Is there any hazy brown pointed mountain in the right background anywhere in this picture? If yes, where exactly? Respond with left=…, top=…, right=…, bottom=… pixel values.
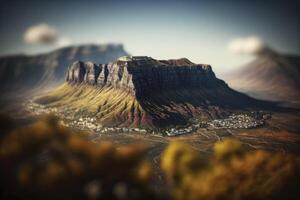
left=224, top=49, right=300, bottom=103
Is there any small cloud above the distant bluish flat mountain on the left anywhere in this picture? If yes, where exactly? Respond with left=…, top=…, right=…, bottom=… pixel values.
left=24, top=23, right=57, bottom=44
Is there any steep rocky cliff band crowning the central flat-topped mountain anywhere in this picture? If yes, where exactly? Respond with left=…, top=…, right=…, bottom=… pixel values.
left=66, top=57, right=226, bottom=97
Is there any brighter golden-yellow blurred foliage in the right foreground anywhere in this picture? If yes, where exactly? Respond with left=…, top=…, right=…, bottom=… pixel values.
left=161, top=140, right=300, bottom=200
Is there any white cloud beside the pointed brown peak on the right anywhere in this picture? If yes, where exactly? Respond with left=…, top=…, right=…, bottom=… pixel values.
left=228, top=36, right=266, bottom=54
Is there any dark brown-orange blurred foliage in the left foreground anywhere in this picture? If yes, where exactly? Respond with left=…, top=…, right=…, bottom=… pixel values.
left=0, top=116, right=156, bottom=199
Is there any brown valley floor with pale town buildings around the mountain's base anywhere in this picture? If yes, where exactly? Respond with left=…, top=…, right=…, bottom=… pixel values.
left=24, top=98, right=300, bottom=153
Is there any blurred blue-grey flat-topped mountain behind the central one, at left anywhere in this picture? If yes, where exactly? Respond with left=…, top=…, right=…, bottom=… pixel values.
left=0, top=44, right=128, bottom=94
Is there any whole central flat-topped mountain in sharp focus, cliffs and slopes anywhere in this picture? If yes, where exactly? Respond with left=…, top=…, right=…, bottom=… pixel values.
left=36, top=56, right=274, bottom=127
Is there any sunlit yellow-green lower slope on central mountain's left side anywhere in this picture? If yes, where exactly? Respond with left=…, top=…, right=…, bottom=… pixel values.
left=35, top=84, right=151, bottom=127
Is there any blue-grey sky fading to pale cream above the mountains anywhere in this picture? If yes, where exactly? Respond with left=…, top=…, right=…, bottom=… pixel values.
left=0, top=0, right=300, bottom=72
